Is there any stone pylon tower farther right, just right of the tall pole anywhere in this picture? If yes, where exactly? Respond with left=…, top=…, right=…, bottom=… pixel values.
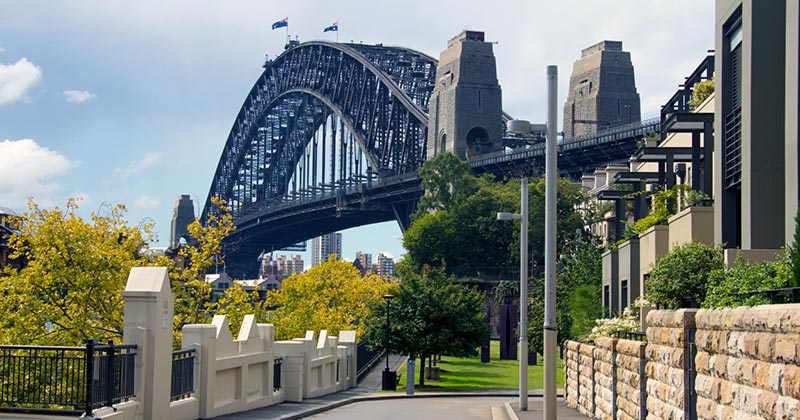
left=564, top=41, right=641, bottom=141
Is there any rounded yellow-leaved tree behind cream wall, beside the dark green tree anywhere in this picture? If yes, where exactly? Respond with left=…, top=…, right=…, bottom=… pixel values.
left=267, top=257, right=393, bottom=340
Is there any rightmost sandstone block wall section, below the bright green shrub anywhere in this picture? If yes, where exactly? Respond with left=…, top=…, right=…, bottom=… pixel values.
left=695, top=304, right=800, bottom=419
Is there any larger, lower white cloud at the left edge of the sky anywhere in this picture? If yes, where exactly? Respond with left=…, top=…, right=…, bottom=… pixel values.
left=0, top=139, right=78, bottom=209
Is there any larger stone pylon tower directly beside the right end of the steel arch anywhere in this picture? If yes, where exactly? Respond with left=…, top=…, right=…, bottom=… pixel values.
left=427, top=31, right=503, bottom=159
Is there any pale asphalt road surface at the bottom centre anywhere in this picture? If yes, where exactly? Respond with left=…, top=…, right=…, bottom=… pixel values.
left=309, top=397, right=513, bottom=420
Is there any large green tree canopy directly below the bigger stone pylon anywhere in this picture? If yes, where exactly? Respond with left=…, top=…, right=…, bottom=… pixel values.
left=403, top=153, right=585, bottom=276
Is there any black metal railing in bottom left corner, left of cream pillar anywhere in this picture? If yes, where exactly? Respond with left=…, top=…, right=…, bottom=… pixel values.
left=0, top=340, right=136, bottom=416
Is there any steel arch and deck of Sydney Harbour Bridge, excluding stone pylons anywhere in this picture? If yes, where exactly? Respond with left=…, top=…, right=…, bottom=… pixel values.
left=203, top=34, right=659, bottom=276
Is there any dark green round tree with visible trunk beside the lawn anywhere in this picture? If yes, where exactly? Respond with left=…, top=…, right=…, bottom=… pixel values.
left=366, top=263, right=489, bottom=386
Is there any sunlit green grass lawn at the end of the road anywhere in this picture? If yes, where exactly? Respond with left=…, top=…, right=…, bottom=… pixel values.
left=397, top=341, right=564, bottom=392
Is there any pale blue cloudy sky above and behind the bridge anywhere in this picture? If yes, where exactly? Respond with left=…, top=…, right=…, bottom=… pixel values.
left=0, top=0, right=714, bottom=266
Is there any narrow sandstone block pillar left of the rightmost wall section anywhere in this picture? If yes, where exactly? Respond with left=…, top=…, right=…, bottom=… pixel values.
left=645, top=309, right=697, bottom=420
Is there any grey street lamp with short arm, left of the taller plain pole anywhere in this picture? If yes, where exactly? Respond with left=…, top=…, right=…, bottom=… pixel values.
left=497, top=178, right=528, bottom=411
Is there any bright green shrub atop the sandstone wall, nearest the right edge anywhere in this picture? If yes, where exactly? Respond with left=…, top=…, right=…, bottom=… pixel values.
left=703, top=254, right=791, bottom=308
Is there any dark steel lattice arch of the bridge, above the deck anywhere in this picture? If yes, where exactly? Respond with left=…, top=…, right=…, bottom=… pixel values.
left=203, top=41, right=437, bottom=224
